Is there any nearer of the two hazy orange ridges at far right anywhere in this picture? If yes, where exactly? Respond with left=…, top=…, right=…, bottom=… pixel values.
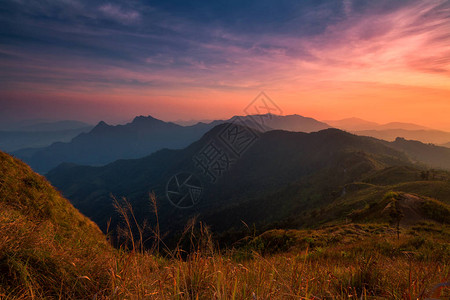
left=352, top=129, right=450, bottom=145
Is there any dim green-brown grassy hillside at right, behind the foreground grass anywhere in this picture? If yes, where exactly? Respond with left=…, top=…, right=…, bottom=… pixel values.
left=207, top=166, right=450, bottom=243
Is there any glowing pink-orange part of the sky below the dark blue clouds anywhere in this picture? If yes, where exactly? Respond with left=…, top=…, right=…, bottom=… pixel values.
left=0, top=0, right=450, bottom=131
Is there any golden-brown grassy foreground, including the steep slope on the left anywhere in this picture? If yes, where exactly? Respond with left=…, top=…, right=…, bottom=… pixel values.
left=0, top=152, right=450, bottom=299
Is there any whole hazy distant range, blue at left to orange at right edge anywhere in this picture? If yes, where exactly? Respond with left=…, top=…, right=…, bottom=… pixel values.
left=6, top=114, right=450, bottom=173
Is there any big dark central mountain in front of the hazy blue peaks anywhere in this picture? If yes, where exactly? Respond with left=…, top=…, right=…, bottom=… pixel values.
left=47, top=124, right=450, bottom=241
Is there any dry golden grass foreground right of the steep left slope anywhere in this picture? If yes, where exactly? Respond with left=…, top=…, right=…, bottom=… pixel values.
left=66, top=196, right=450, bottom=299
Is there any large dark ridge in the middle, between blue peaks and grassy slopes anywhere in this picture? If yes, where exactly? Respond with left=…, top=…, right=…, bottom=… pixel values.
left=47, top=124, right=440, bottom=239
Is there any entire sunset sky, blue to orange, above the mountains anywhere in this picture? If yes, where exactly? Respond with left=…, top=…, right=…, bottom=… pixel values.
left=0, top=0, right=450, bottom=131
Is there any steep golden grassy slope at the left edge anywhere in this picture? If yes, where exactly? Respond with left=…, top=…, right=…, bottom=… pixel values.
left=0, top=152, right=112, bottom=299
